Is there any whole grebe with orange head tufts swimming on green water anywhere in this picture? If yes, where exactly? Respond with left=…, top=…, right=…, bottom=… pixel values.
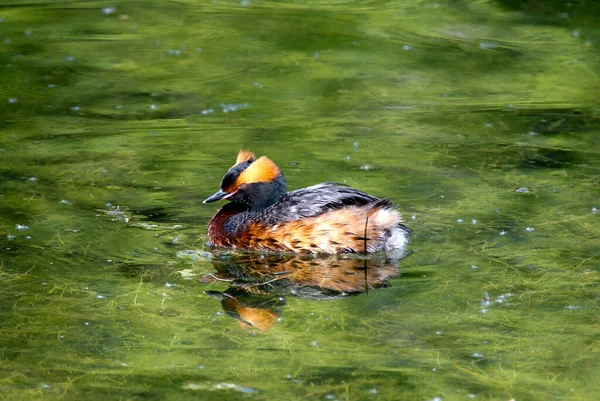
left=203, top=150, right=412, bottom=255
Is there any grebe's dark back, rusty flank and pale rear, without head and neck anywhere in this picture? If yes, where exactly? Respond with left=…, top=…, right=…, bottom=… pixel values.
left=231, top=183, right=407, bottom=253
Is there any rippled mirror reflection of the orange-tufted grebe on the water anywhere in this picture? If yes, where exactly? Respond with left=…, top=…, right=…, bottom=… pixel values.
left=202, top=252, right=399, bottom=331
